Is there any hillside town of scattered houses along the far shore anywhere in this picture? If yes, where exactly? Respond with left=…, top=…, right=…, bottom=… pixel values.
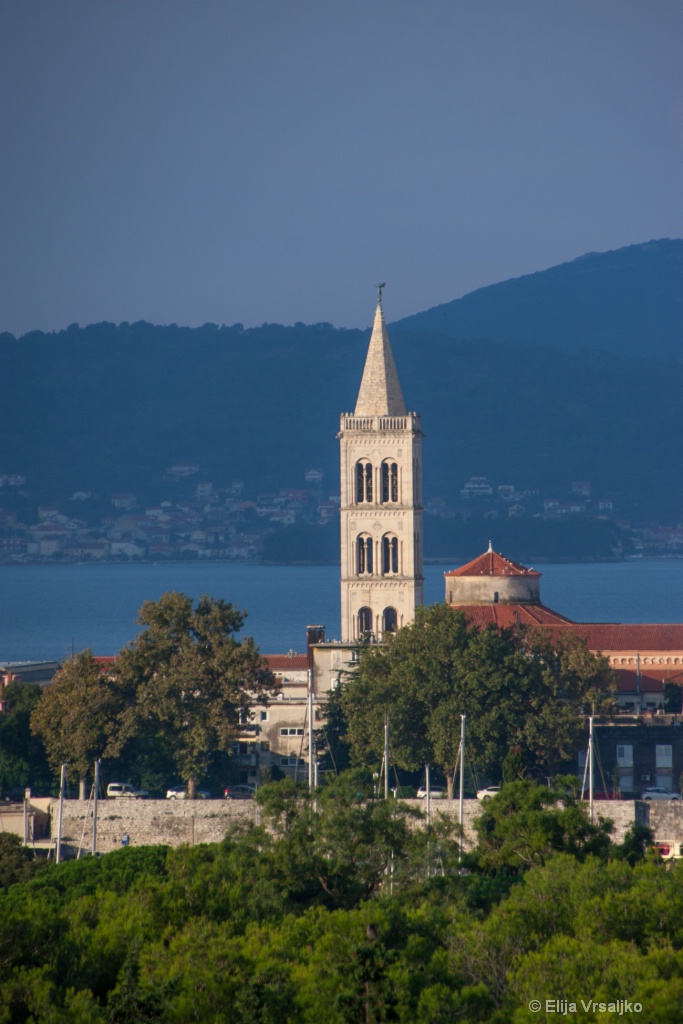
left=0, top=464, right=683, bottom=564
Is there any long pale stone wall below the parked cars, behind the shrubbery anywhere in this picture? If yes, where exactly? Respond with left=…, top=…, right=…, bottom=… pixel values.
left=50, top=799, right=643, bottom=855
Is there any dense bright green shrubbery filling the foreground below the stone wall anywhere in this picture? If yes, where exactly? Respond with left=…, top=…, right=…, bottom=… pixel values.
left=0, top=771, right=683, bottom=1024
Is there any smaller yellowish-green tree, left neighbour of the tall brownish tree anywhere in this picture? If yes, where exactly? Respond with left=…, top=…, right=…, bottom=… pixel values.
left=31, top=648, right=133, bottom=796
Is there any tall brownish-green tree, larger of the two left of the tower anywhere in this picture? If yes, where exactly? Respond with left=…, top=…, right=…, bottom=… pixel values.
left=117, top=593, right=275, bottom=797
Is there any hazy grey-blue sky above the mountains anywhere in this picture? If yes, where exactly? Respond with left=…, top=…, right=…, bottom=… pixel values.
left=0, top=0, right=683, bottom=334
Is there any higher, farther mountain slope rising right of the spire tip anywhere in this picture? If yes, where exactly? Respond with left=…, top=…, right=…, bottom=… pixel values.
left=391, top=239, right=683, bottom=359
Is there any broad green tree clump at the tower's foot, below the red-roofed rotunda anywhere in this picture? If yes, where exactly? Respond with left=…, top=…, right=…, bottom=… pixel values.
left=339, top=604, right=612, bottom=785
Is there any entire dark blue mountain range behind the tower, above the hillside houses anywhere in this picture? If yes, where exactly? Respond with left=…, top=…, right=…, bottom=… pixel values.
left=0, top=241, right=683, bottom=523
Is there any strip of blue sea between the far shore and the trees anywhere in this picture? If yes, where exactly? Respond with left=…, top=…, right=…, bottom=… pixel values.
left=0, top=559, right=683, bottom=662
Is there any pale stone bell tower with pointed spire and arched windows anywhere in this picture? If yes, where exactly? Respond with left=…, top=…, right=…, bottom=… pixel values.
left=338, top=299, right=424, bottom=642
